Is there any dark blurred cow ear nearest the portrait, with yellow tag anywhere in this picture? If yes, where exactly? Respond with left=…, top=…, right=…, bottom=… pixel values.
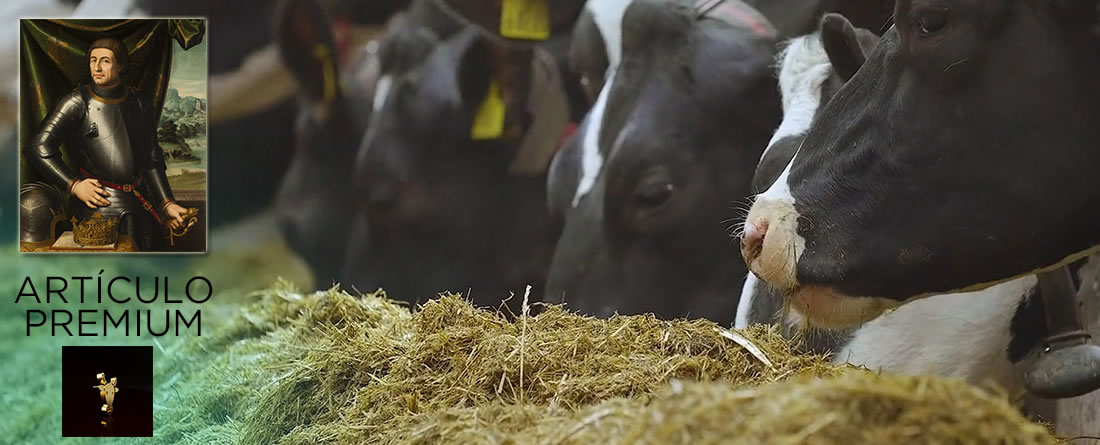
left=275, top=0, right=341, bottom=104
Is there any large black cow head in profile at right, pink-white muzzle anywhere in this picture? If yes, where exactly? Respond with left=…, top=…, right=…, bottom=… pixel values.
left=743, top=0, right=1100, bottom=326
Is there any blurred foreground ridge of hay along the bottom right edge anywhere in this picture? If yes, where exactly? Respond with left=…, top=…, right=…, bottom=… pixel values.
left=394, top=371, right=1059, bottom=445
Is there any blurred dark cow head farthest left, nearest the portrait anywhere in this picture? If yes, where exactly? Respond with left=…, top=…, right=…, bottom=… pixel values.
left=275, top=0, right=377, bottom=287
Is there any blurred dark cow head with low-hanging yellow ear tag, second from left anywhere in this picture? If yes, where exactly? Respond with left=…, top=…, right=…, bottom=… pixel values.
left=345, top=27, right=569, bottom=304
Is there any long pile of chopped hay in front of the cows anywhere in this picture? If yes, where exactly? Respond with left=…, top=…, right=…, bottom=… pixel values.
left=155, top=283, right=1055, bottom=444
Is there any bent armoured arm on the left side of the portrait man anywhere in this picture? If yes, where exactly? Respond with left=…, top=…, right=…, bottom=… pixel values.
left=23, top=91, right=85, bottom=192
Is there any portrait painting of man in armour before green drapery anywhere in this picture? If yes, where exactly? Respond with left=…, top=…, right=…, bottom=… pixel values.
left=19, top=18, right=209, bottom=254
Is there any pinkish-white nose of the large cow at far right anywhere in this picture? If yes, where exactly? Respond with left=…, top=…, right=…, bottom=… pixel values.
left=743, top=198, right=806, bottom=291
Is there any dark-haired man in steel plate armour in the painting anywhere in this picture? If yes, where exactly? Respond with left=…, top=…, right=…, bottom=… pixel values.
left=24, top=38, right=187, bottom=252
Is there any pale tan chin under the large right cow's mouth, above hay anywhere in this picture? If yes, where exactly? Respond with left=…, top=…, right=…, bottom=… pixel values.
left=788, top=286, right=901, bottom=330
